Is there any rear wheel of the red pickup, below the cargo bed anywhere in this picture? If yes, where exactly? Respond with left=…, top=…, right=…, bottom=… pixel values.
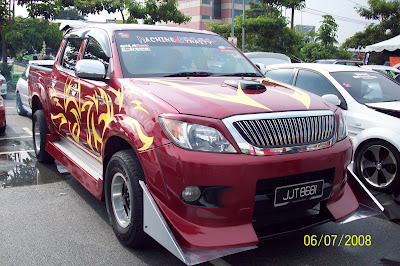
left=32, top=109, right=54, bottom=163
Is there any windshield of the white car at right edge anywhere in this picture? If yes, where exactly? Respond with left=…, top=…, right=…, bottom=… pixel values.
left=331, top=71, right=400, bottom=103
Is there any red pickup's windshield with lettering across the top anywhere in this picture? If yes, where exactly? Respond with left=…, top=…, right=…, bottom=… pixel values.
left=116, top=30, right=261, bottom=78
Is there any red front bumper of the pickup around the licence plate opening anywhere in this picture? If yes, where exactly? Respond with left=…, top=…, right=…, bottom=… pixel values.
left=143, top=138, right=358, bottom=249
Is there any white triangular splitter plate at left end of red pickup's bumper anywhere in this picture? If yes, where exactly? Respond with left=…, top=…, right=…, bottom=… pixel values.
left=139, top=181, right=257, bottom=265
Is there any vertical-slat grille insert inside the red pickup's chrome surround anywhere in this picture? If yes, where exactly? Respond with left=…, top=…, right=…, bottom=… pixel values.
left=233, top=113, right=335, bottom=148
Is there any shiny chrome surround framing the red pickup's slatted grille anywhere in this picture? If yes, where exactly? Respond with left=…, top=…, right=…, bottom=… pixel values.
left=222, top=110, right=337, bottom=155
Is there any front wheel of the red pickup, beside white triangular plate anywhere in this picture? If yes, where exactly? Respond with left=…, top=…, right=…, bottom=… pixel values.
left=105, top=150, right=151, bottom=248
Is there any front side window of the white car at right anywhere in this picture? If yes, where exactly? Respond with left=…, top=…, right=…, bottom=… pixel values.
left=295, top=70, right=346, bottom=109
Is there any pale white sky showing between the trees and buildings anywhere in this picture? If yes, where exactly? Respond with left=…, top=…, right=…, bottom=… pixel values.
left=16, top=0, right=377, bottom=44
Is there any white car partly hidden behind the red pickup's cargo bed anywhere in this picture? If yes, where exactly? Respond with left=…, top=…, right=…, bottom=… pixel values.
left=15, top=60, right=54, bottom=116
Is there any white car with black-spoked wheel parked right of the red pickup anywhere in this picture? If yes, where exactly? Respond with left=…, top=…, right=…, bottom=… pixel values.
left=265, top=63, right=400, bottom=192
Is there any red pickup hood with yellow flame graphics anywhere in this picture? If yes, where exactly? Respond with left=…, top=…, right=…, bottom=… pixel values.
left=122, top=77, right=335, bottom=119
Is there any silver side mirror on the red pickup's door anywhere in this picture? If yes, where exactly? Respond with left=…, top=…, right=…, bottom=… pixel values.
left=75, top=59, right=106, bottom=80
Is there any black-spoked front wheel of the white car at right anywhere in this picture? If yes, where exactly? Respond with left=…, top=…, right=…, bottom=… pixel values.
left=356, top=140, right=400, bottom=192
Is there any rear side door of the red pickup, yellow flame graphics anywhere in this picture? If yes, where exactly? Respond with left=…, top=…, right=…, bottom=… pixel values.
left=49, top=36, right=83, bottom=142
